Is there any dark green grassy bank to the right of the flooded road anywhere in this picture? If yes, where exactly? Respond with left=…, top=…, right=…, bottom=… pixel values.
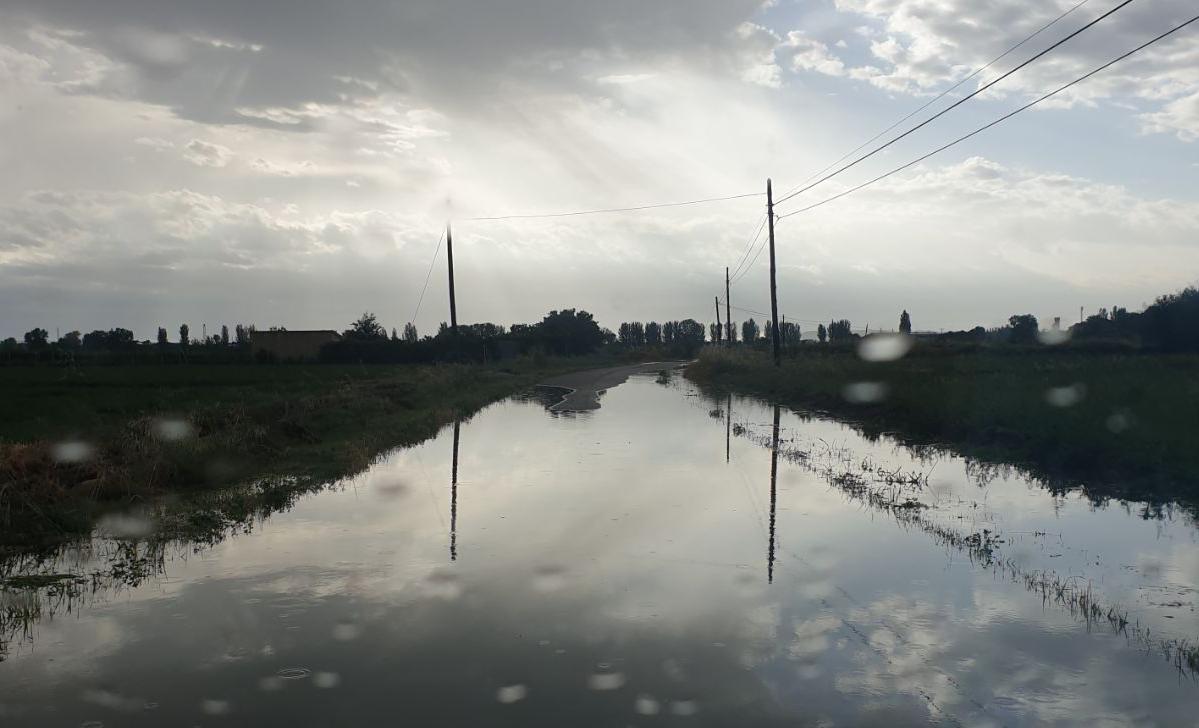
left=687, top=343, right=1199, bottom=503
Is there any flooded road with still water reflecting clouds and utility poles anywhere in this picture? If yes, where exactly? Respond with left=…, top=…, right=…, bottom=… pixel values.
left=0, top=374, right=1199, bottom=727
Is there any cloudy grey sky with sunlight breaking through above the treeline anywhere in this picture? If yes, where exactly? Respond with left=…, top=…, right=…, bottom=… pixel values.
left=0, top=0, right=1199, bottom=339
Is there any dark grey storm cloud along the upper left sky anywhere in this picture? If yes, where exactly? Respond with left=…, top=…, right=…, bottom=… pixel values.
left=2, top=0, right=760, bottom=126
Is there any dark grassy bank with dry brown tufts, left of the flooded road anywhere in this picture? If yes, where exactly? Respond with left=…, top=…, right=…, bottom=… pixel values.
left=0, top=357, right=610, bottom=543
